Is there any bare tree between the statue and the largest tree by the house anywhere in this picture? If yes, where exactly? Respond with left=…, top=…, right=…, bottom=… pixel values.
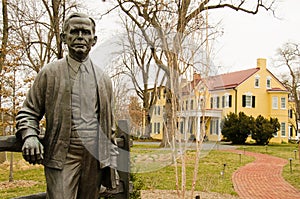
left=120, top=17, right=165, bottom=137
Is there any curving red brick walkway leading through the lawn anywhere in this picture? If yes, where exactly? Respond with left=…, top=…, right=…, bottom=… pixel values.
left=229, top=150, right=300, bottom=199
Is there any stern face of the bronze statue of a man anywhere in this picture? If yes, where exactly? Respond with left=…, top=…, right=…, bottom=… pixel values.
left=62, top=17, right=97, bottom=61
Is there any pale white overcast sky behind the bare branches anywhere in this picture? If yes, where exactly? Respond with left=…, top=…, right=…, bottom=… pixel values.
left=85, top=0, right=300, bottom=73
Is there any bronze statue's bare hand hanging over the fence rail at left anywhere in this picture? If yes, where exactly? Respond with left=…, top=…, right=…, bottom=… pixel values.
left=22, top=136, right=44, bottom=164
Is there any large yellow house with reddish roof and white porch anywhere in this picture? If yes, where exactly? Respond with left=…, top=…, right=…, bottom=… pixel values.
left=152, top=58, right=297, bottom=143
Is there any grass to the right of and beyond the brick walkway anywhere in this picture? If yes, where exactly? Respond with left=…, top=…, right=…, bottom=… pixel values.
left=239, top=143, right=300, bottom=190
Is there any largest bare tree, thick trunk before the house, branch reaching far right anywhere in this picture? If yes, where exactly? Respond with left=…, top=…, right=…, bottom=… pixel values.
left=112, top=0, right=275, bottom=198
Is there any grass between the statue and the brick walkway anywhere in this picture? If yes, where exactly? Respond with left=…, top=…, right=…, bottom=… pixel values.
left=132, top=145, right=254, bottom=195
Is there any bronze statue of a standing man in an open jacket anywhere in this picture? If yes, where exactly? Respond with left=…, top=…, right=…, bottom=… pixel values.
left=16, top=13, right=118, bottom=199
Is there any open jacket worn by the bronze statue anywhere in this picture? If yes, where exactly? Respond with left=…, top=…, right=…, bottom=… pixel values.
left=16, top=58, right=115, bottom=188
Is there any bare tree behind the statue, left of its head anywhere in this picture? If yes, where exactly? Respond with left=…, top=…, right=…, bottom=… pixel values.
left=9, top=0, right=77, bottom=72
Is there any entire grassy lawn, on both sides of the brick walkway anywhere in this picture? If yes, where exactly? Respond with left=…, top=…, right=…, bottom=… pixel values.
left=0, top=144, right=300, bottom=199
